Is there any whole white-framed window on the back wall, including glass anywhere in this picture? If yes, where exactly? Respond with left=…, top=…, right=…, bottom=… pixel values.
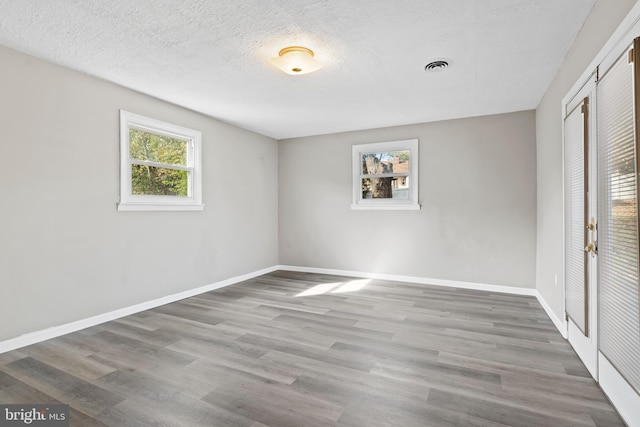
left=351, top=139, right=420, bottom=210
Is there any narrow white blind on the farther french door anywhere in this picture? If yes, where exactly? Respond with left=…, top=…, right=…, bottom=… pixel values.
left=564, top=101, right=587, bottom=335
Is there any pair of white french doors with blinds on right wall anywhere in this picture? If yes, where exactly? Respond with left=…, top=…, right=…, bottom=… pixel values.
left=563, top=39, right=640, bottom=427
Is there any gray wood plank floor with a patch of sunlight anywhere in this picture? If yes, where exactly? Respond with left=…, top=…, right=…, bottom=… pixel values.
left=0, top=271, right=624, bottom=427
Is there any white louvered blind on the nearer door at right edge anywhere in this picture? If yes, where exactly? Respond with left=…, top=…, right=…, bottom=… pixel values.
left=597, top=47, right=640, bottom=391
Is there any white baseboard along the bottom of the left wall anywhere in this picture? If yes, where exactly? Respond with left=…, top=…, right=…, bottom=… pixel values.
left=0, top=266, right=278, bottom=354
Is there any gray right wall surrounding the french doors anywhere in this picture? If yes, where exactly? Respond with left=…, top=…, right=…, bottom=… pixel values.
left=536, top=0, right=636, bottom=318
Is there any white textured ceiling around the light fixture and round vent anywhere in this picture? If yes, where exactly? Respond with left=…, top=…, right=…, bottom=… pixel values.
left=0, top=0, right=595, bottom=139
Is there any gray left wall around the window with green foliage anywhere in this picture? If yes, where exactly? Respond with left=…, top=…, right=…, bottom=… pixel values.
left=0, top=47, right=278, bottom=340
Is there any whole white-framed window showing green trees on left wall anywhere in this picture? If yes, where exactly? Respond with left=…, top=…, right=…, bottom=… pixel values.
left=118, top=110, right=204, bottom=211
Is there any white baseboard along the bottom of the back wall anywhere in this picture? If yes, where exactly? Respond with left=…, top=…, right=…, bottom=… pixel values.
left=277, top=265, right=537, bottom=296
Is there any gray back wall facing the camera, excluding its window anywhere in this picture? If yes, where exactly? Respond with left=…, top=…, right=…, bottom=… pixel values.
left=279, top=111, right=536, bottom=288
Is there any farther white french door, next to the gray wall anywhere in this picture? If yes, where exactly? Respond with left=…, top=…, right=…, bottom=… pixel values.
left=564, top=74, right=598, bottom=379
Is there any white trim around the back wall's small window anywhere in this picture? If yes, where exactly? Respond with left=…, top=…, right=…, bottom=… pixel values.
left=351, top=139, right=420, bottom=210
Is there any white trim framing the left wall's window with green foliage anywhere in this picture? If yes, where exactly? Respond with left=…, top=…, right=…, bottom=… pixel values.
left=118, top=110, right=204, bottom=211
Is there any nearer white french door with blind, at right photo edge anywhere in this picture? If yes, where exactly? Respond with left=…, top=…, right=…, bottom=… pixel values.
left=597, top=39, right=640, bottom=426
